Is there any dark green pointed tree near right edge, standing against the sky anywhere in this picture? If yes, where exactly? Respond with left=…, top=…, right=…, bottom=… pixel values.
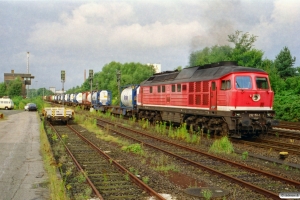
left=274, top=47, right=296, bottom=79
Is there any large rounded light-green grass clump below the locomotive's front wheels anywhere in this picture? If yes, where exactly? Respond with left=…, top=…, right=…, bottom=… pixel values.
left=209, top=136, right=234, bottom=154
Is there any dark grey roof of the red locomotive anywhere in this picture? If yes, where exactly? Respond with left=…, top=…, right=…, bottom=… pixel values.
left=141, top=61, right=266, bottom=86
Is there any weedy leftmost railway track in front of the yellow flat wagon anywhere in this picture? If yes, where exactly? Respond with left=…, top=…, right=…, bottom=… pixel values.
left=47, top=125, right=164, bottom=200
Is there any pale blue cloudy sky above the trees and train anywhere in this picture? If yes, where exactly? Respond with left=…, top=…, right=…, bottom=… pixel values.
left=0, top=0, right=300, bottom=90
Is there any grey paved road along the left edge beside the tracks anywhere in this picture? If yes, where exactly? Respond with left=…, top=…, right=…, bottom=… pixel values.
left=0, top=110, right=49, bottom=200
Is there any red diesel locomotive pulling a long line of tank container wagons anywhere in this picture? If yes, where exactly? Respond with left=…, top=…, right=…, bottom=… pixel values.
left=46, top=61, right=278, bottom=138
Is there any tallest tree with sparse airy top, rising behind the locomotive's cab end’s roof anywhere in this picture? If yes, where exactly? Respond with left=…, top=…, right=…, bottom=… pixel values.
left=228, top=31, right=264, bottom=67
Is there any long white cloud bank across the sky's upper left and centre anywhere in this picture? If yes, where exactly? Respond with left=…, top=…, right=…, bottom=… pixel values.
left=29, top=3, right=202, bottom=50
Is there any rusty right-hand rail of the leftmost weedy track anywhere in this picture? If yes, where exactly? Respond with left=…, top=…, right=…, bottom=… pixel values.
left=67, top=125, right=165, bottom=200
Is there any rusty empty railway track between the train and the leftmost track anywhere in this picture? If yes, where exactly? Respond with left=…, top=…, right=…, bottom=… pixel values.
left=97, top=116, right=300, bottom=199
